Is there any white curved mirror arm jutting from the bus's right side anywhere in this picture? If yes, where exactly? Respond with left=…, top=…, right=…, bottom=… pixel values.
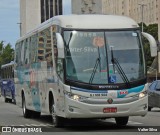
left=142, top=32, right=157, bottom=57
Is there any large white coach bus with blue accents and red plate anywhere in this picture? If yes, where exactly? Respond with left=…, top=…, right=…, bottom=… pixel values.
left=15, top=15, right=157, bottom=127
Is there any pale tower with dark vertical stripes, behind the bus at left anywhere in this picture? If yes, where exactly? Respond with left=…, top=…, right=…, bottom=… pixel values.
left=19, top=0, right=62, bottom=36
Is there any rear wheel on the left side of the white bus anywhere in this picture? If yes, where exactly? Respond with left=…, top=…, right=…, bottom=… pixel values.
left=22, top=95, right=32, bottom=118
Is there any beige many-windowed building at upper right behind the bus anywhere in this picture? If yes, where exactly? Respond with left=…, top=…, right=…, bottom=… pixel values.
left=102, top=0, right=160, bottom=41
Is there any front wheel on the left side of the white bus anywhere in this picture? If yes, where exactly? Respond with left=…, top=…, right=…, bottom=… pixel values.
left=52, top=105, right=64, bottom=127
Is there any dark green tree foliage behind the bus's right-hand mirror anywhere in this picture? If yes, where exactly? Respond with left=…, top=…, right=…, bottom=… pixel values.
left=139, top=23, right=158, bottom=67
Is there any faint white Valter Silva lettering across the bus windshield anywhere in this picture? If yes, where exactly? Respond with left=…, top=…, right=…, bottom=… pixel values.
left=67, top=47, right=97, bottom=53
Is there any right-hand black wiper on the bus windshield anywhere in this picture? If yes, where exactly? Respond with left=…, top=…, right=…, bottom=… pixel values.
left=111, top=47, right=130, bottom=87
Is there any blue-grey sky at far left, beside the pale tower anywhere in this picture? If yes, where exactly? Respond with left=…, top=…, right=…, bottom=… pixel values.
left=0, top=0, right=20, bottom=48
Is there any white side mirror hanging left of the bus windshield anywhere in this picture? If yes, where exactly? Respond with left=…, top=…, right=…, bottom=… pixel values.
left=56, top=33, right=64, bottom=58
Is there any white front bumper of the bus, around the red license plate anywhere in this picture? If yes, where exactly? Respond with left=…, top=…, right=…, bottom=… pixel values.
left=65, top=96, right=148, bottom=118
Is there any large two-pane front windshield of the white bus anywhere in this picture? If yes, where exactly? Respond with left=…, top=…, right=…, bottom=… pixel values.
left=64, top=30, right=145, bottom=84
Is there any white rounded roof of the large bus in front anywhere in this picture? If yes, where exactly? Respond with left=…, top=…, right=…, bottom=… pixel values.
left=17, top=14, right=139, bottom=42
